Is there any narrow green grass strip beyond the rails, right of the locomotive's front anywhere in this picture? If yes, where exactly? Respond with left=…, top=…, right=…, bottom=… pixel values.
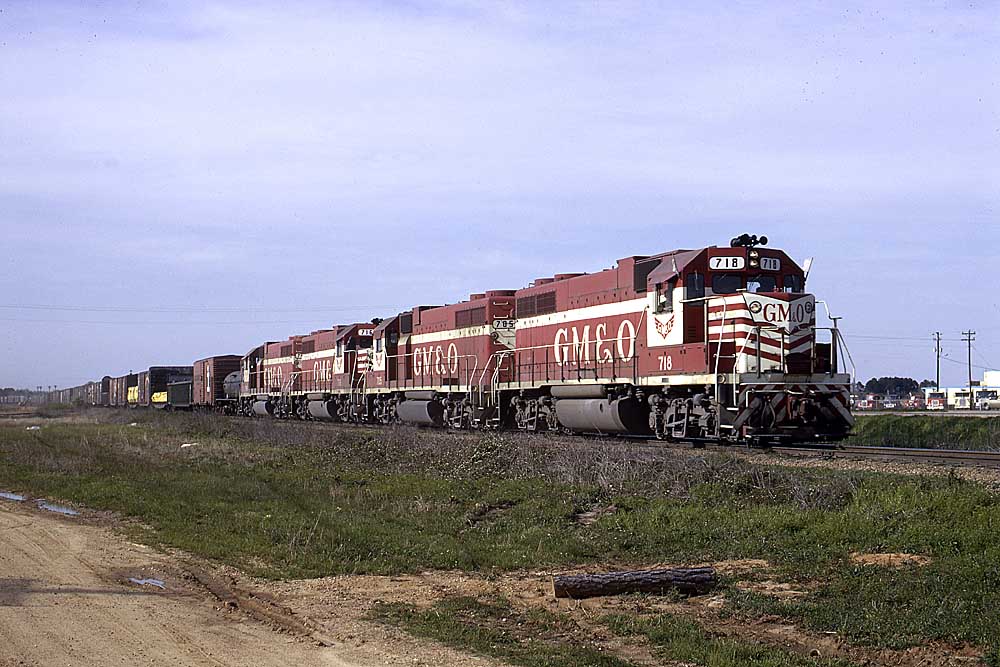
left=848, top=414, right=1000, bottom=451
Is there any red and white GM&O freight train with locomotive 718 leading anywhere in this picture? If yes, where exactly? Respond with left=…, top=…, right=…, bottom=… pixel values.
left=45, top=234, right=853, bottom=445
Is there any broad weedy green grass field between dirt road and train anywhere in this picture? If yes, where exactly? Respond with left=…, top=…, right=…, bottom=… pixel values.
left=0, top=411, right=1000, bottom=664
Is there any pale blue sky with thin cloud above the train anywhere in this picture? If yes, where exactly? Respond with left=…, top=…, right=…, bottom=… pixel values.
left=0, top=1, right=1000, bottom=387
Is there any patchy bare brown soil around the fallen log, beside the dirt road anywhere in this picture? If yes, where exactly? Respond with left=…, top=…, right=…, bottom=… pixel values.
left=253, top=559, right=982, bottom=667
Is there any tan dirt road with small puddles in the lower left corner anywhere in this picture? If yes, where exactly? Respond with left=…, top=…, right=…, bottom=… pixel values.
left=0, top=499, right=500, bottom=667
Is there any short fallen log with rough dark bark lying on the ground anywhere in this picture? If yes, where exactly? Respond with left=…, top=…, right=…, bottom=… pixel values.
left=552, top=567, right=718, bottom=600
